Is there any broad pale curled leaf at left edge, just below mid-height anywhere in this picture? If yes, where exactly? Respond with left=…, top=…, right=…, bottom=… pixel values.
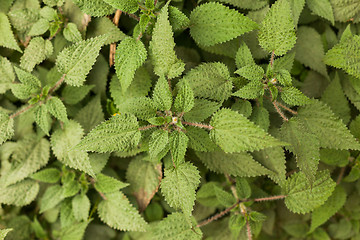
left=0, top=136, right=50, bottom=187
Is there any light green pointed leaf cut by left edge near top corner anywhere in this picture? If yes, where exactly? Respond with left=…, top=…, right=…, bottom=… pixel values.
left=0, top=12, right=22, bottom=52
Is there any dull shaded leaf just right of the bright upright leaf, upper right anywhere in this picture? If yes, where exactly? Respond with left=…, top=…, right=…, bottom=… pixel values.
left=295, top=27, right=328, bottom=77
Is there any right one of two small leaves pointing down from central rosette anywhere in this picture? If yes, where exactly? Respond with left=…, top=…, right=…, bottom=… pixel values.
left=169, top=130, right=189, bottom=166
